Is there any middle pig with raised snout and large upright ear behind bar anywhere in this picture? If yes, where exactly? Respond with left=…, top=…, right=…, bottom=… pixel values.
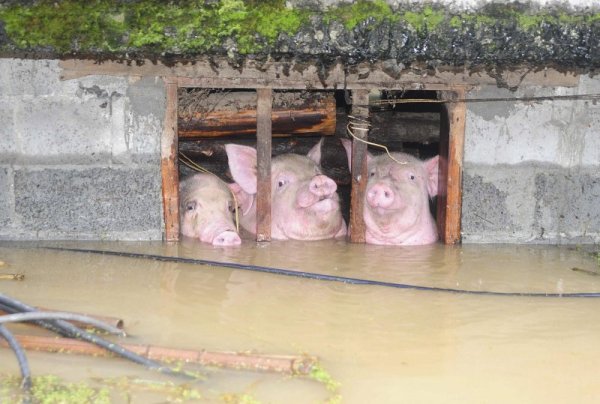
left=225, top=141, right=347, bottom=240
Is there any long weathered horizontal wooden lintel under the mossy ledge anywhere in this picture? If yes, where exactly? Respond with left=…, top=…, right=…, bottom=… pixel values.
left=59, top=57, right=579, bottom=90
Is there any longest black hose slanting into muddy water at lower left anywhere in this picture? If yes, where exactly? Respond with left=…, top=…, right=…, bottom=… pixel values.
left=0, top=293, right=192, bottom=378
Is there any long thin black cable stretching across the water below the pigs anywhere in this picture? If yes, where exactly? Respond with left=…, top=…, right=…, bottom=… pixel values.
left=41, top=247, right=600, bottom=298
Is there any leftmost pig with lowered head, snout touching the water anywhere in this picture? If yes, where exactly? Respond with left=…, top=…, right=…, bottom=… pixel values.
left=179, top=173, right=242, bottom=246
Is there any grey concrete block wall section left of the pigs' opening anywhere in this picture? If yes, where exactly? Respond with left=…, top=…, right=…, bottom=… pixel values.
left=0, top=59, right=165, bottom=240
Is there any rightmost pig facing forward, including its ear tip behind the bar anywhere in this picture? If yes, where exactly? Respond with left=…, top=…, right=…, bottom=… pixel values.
left=342, top=139, right=439, bottom=245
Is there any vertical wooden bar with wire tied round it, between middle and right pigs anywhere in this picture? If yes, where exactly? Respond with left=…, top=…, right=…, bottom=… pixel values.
left=349, top=90, right=369, bottom=243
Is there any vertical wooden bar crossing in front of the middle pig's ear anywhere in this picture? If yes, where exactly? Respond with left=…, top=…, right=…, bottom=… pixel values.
left=256, top=88, right=273, bottom=241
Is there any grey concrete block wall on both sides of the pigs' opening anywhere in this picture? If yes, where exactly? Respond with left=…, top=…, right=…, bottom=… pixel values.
left=0, top=59, right=600, bottom=243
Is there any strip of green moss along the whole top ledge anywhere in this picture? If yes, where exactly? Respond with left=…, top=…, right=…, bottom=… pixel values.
left=0, top=0, right=600, bottom=58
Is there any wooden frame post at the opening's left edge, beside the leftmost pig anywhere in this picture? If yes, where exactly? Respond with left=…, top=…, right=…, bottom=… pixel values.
left=160, top=79, right=179, bottom=241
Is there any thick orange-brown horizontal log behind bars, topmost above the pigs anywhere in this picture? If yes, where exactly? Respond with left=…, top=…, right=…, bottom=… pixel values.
left=178, top=90, right=336, bottom=139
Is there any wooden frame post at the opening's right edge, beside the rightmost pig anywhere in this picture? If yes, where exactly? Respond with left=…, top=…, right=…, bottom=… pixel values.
left=437, top=89, right=467, bottom=244
